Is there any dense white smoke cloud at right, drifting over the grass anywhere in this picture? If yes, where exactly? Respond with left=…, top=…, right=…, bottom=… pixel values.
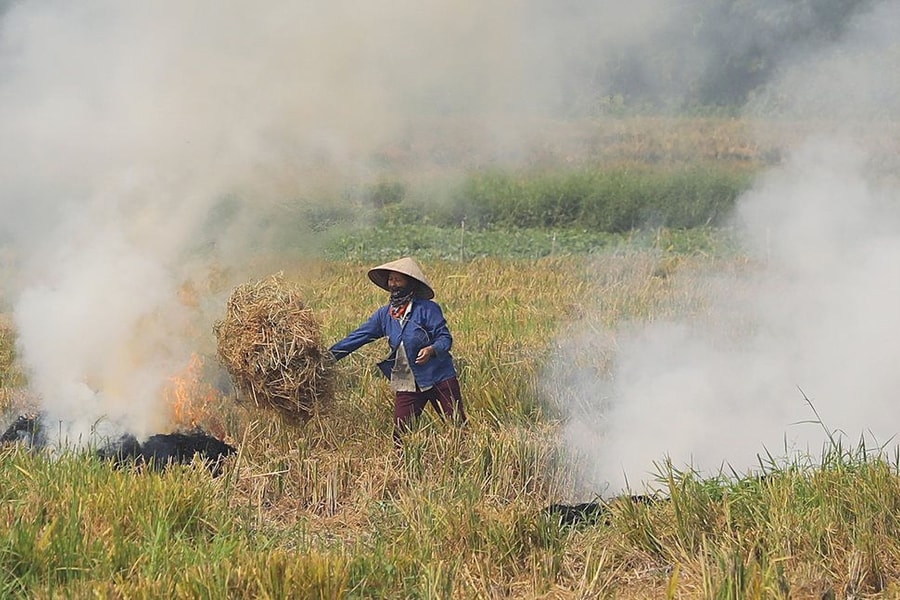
left=553, top=3, right=900, bottom=494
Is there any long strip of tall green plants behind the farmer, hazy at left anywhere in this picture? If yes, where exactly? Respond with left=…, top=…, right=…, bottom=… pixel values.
left=295, top=163, right=756, bottom=239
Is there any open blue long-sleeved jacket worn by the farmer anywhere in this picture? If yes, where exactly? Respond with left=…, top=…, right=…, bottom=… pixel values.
left=331, top=299, right=456, bottom=389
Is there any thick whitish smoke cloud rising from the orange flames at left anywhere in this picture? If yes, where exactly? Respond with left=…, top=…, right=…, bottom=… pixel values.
left=0, top=0, right=684, bottom=443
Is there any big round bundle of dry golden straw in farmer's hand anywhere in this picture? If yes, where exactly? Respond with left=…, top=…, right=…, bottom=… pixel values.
left=213, top=274, right=333, bottom=418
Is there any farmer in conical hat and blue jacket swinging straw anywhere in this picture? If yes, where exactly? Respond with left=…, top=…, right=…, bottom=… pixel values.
left=331, top=257, right=466, bottom=445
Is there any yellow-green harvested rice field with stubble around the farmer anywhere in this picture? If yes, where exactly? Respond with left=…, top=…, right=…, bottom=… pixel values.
left=0, top=247, right=900, bottom=599
